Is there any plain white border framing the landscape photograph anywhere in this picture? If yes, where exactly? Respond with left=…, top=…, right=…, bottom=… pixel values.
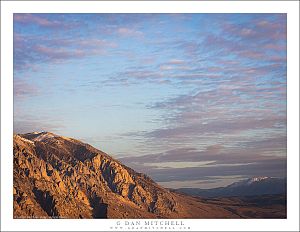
left=1, top=1, right=299, bottom=231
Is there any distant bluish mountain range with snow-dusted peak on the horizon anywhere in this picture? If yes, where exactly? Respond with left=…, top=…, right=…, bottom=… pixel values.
left=174, top=176, right=287, bottom=197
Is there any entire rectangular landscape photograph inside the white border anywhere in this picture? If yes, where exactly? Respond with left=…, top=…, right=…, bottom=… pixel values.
left=13, top=13, right=287, bottom=219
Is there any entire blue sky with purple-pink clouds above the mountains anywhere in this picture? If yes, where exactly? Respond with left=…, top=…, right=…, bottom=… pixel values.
left=13, top=14, right=287, bottom=188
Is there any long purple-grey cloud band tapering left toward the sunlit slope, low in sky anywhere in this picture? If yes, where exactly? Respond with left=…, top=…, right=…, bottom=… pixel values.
left=122, top=136, right=287, bottom=165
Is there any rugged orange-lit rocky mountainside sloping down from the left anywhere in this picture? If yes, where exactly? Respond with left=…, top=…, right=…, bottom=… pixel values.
left=13, top=132, right=240, bottom=218
